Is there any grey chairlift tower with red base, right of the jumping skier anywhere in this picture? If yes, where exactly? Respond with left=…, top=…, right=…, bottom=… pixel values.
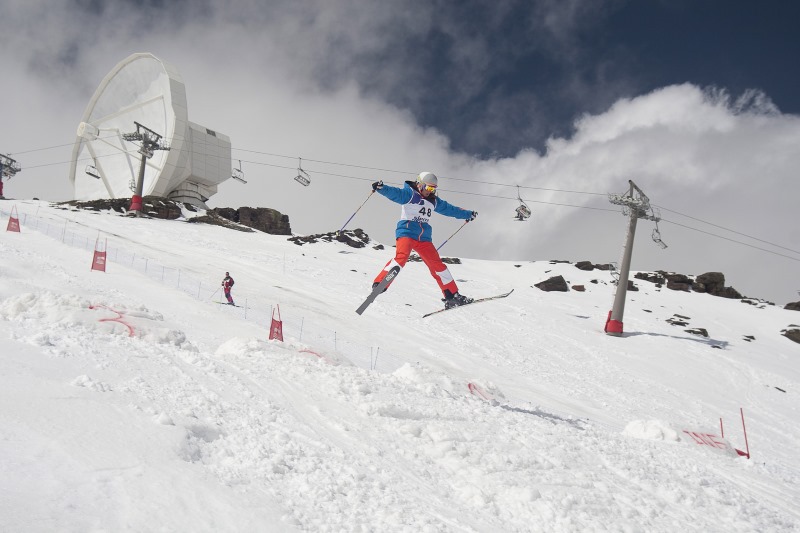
left=604, top=180, right=667, bottom=337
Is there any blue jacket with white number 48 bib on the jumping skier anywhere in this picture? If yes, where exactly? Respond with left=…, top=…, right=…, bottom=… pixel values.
left=378, top=181, right=472, bottom=242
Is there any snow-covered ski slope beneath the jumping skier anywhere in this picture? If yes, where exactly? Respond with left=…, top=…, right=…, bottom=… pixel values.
left=0, top=200, right=800, bottom=532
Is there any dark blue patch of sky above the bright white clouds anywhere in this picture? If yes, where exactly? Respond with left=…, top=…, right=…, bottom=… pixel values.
left=284, top=0, right=800, bottom=157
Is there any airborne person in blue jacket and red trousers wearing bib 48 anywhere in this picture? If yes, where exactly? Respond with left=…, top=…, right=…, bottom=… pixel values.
left=372, top=172, right=478, bottom=309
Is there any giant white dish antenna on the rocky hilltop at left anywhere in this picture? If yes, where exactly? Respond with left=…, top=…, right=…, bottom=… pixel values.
left=69, top=53, right=232, bottom=208
